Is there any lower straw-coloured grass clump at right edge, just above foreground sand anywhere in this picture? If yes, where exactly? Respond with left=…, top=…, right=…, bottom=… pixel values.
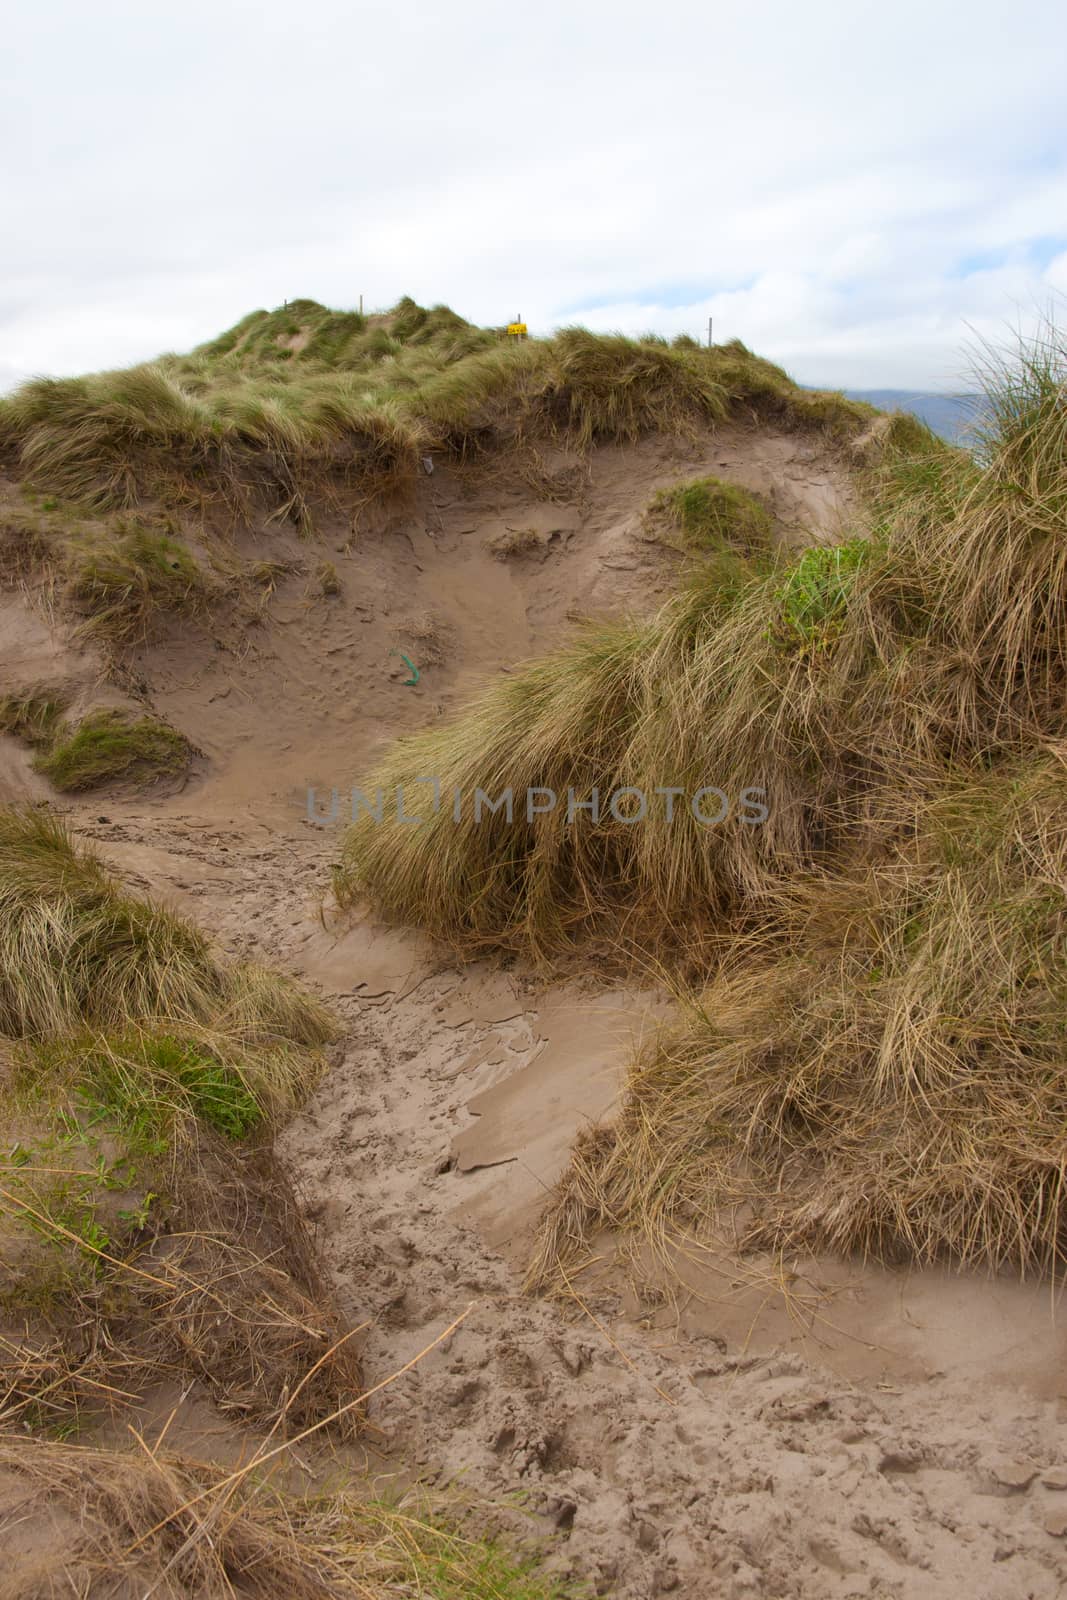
left=534, top=746, right=1067, bottom=1283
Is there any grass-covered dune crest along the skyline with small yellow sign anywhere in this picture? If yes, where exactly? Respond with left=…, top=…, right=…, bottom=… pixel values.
left=0, top=299, right=902, bottom=508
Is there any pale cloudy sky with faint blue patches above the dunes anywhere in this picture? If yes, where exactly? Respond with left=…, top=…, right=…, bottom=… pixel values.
left=0, top=0, right=1067, bottom=390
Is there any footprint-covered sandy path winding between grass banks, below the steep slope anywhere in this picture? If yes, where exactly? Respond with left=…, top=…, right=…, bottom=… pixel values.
left=66, top=813, right=1067, bottom=1600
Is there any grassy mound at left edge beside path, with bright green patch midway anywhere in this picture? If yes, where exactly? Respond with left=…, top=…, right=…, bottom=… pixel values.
left=0, top=811, right=348, bottom=1429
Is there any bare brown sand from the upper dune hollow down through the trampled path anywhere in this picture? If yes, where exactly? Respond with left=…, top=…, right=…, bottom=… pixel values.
left=8, top=430, right=1067, bottom=1600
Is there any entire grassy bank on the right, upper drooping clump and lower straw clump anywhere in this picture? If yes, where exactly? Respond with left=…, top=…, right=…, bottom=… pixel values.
left=338, top=334, right=1067, bottom=1278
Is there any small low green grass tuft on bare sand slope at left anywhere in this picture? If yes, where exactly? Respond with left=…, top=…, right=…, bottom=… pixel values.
left=34, top=710, right=192, bottom=794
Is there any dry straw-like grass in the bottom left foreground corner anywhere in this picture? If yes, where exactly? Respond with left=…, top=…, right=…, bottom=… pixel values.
left=0, top=1437, right=573, bottom=1600
